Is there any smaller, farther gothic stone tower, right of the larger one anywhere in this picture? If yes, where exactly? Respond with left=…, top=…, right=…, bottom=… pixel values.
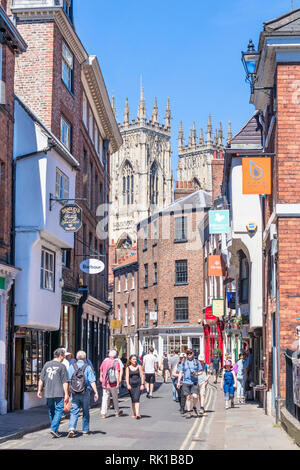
left=175, top=115, right=232, bottom=200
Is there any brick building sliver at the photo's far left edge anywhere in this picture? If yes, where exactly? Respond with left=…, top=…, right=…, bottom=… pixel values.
left=0, top=0, right=27, bottom=414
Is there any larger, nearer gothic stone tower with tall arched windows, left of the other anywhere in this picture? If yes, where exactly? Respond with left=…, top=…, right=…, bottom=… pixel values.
left=110, top=88, right=173, bottom=262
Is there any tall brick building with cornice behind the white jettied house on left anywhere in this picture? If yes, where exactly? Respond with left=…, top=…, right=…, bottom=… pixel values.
left=10, top=0, right=122, bottom=410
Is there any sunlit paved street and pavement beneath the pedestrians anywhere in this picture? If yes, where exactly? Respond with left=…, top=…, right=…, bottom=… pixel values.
left=0, top=383, right=298, bottom=451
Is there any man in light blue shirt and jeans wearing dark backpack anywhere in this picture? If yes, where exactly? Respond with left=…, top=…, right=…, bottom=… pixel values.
left=68, top=351, right=99, bottom=438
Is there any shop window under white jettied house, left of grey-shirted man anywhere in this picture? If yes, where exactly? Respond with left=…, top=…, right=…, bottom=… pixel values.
left=25, top=330, right=49, bottom=392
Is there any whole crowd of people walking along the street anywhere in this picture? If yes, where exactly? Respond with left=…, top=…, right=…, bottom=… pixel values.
left=37, top=347, right=252, bottom=438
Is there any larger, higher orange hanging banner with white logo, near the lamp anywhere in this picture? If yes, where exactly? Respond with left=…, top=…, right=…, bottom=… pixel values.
left=243, top=157, right=272, bottom=194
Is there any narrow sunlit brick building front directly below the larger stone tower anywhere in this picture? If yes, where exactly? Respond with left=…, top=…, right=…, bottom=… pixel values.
left=111, top=251, right=138, bottom=357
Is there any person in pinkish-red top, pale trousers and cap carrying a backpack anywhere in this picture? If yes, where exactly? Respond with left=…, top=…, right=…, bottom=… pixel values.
left=100, top=349, right=123, bottom=418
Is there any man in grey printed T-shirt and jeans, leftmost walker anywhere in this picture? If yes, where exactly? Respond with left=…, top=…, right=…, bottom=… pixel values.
left=37, top=348, right=69, bottom=438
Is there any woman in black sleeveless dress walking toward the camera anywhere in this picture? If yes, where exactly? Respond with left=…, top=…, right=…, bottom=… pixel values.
left=125, top=354, right=145, bottom=419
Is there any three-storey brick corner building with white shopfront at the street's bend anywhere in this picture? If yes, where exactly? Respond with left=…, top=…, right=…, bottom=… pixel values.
left=137, top=191, right=211, bottom=358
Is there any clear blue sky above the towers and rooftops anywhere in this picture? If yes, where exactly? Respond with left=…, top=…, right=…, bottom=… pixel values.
left=74, top=0, right=300, bottom=176
